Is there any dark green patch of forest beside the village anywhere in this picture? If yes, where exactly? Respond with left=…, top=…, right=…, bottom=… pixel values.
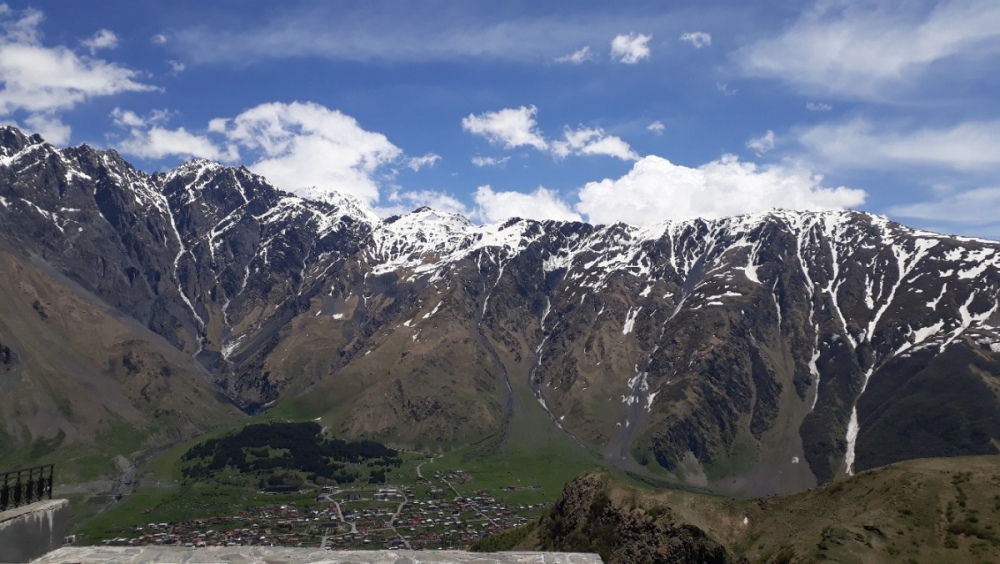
left=181, top=421, right=403, bottom=487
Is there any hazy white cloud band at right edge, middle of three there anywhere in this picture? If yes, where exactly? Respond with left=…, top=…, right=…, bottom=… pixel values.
left=799, top=118, right=1000, bottom=171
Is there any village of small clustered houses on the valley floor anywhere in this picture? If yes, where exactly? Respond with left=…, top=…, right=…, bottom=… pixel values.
left=94, top=467, right=546, bottom=550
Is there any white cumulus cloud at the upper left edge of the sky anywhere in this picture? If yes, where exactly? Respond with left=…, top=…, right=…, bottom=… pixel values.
left=0, top=6, right=154, bottom=142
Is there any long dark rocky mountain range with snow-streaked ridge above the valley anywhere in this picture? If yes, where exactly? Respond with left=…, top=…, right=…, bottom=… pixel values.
left=0, top=128, right=1000, bottom=493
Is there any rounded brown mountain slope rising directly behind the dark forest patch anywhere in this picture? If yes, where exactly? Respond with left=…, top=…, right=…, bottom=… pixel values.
left=259, top=266, right=511, bottom=448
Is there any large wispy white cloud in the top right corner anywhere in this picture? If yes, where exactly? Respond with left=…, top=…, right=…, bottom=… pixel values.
left=735, top=0, right=1000, bottom=98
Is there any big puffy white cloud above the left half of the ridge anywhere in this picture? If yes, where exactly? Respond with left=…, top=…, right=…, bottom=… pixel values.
left=221, top=102, right=402, bottom=204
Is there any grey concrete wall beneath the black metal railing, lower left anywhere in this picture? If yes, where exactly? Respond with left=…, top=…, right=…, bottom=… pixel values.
left=0, top=499, right=69, bottom=562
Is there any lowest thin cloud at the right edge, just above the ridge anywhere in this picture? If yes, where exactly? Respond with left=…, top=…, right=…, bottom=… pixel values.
left=889, top=187, right=1000, bottom=225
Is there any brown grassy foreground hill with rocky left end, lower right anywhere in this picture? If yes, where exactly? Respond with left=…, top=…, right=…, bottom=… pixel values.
left=483, top=456, right=1000, bottom=564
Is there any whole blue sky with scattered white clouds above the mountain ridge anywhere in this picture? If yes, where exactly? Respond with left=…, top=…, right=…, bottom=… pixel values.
left=0, top=0, right=1000, bottom=238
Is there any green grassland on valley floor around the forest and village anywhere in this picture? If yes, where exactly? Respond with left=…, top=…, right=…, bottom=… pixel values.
left=72, top=408, right=597, bottom=544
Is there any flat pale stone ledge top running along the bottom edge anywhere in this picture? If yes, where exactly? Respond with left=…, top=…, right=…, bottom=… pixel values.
left=35, top=546, right=602, bottom=564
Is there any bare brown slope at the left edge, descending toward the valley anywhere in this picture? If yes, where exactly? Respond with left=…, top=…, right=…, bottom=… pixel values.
left=0, top=249, right=240, bottom=482
